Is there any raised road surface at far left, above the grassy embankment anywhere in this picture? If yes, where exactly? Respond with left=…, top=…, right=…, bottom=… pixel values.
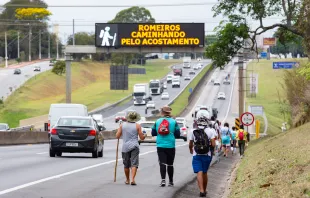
left=0, top=61, right=52, bottom=99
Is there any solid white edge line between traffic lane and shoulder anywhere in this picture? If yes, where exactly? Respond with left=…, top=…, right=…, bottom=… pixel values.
left=0, top=143, right=188, bottom=195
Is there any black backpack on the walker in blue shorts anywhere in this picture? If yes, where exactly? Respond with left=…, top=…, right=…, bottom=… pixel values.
left=193, top=129, right=210, bottom=155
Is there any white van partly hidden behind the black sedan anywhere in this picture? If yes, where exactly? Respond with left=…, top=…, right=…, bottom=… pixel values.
left=48, top=103, right=88, bottom=130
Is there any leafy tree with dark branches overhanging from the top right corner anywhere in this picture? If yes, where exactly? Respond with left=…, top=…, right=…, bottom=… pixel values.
left=207, top=0, right=310, bottom=66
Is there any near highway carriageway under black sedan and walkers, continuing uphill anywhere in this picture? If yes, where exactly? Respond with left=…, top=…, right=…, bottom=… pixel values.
left=0, top=59, right=238, bottom=198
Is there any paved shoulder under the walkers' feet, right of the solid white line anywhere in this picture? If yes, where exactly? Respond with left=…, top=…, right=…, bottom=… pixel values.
left=0, top=141, right=193, bottom=198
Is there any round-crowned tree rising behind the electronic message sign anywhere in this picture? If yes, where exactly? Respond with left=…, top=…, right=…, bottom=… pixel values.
left=109, top=6, right=155, bottom=65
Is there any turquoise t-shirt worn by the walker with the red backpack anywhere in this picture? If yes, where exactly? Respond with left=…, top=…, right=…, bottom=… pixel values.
left=152, top=117, right=180, bottom=148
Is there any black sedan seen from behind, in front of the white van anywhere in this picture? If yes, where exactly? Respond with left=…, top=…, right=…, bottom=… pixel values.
left=49, top=116, right=104, bottom=158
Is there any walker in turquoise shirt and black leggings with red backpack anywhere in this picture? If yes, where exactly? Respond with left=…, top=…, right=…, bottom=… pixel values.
left=152, top=106, right=180, bottom=187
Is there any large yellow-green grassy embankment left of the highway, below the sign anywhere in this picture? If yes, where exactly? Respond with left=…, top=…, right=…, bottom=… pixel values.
left=0, top=60, right=177, bottom=127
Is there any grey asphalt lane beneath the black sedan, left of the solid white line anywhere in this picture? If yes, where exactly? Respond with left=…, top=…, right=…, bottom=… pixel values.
left=0, top=140, right=126, bottom=191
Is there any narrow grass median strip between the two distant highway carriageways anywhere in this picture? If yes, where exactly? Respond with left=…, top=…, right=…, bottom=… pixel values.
left=171, top=64, right=211, bottom=115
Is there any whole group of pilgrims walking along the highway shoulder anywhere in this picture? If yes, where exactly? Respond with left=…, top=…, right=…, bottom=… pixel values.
left=116, top=106, right=248, bottom=197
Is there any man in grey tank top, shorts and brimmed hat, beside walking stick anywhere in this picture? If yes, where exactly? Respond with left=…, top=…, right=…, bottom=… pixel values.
left=116, top=112, right=145, bottom=185
